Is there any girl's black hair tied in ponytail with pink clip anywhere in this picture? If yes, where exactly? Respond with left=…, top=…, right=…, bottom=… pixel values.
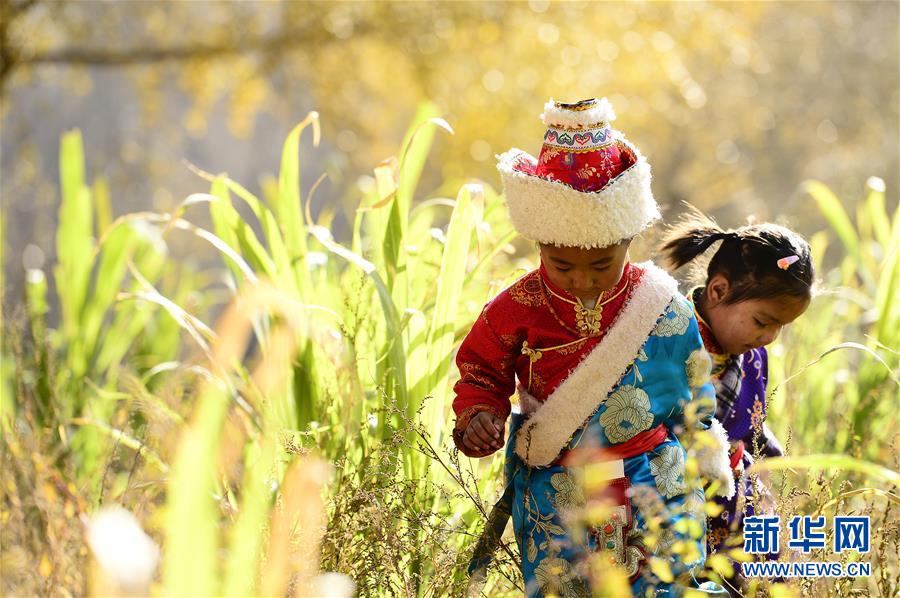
left=660, top=209, right=815, bottom=304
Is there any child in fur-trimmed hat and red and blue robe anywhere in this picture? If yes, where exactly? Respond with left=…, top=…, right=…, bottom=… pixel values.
left=453, top=99, right=731, bottom=596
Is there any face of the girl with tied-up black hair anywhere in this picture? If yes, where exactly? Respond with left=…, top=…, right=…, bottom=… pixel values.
left=703, top=274, right=809, bottom=355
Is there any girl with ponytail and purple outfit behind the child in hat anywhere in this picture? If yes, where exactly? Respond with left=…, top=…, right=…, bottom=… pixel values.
left=661, top=210, right=814, bottom=588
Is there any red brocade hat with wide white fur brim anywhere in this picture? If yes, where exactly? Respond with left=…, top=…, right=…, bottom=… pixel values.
left=497, top=98, right=660, bottom=248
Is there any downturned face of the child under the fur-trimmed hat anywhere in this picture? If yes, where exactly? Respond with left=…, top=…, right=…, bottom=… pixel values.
left=541, top=239, right=631, bottom=301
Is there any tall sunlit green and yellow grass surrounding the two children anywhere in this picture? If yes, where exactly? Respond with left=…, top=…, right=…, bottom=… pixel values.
left=0, top=111, right=900, bottom=596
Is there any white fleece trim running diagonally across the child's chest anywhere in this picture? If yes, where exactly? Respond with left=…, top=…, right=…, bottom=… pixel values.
left=516, top=262, right=678, bottom=467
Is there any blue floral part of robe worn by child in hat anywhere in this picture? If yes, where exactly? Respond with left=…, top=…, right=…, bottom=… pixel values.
left=496, top=296, right=715, bottom=596
